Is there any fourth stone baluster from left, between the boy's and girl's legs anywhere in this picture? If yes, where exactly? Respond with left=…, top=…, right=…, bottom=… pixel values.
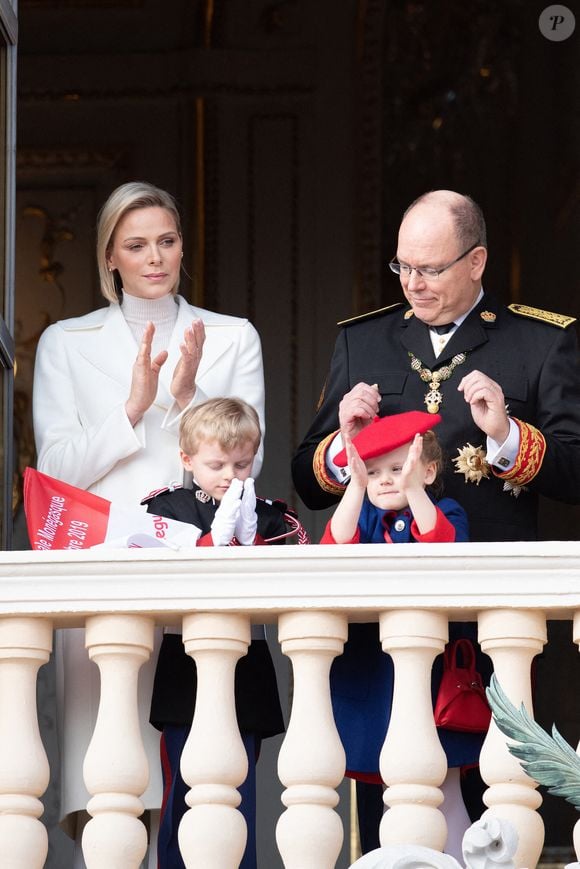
left=276, top=612, right=348, bottom=869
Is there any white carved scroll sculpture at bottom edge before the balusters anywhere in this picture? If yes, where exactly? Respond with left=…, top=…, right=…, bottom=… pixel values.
left=351, top=818, right=518, bottom=869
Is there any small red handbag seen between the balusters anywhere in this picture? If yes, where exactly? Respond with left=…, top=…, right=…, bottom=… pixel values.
left=433, top=638, right=491, bottom=733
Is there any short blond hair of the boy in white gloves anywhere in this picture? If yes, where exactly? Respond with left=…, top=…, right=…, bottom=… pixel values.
left=179, top=398, right=262, bottom=456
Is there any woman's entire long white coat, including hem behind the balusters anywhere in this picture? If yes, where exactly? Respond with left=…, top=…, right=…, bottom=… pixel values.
left=33, top=296, right=264, bottom=818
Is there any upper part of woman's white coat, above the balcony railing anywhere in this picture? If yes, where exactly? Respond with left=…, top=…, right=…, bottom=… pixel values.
left=33, top=296, right=264, bottom=506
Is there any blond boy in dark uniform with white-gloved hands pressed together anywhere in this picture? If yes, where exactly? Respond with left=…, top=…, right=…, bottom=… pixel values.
left=142, top=398, right=288, bottom=869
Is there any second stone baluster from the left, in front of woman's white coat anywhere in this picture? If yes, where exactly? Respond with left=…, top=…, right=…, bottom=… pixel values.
left=83, top=615, right=154, bottom=869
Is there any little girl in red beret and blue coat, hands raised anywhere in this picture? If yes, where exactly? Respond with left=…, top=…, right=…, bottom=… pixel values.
left=320, top=411, right=483, bottom=859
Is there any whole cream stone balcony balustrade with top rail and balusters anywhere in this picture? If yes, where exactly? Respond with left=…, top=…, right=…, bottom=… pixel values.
left=0, top=542, right=580, bottom=869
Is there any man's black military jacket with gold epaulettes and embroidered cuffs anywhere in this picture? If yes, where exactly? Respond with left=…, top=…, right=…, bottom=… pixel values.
left=292, top=295, right=580, bottom=540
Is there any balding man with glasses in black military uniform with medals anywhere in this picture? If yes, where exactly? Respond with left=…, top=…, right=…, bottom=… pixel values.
left=292, top=190, right=580, bottom=540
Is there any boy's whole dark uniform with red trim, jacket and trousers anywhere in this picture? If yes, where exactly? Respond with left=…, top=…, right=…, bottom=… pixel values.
left=141, top=484, right=287, bottom=869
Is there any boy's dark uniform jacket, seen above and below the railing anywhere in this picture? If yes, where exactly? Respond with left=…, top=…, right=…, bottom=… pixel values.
left=144, top=488, right=287, bottom=738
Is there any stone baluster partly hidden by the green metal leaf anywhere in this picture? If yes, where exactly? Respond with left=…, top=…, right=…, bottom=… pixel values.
left=479, top=609, right=546, bottom=869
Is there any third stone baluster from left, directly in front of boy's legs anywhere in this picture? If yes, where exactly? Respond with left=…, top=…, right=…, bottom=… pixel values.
left=179, top=613, right=250, bottom=869
